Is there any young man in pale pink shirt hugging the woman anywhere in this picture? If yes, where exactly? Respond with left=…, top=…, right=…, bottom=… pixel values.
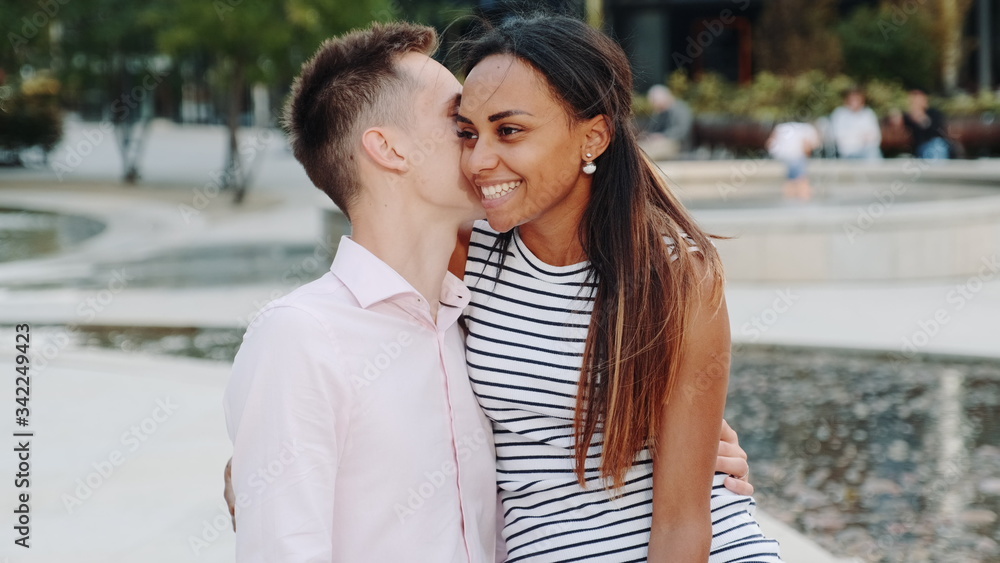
left=225, top=19, right=752, bottom=563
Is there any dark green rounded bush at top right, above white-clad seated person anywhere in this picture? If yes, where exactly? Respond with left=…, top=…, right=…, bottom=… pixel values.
left=837, top=2, right=940, bottom=90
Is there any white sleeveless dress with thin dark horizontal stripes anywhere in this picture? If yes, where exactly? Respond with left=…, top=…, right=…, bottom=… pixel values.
left=465, top=221, right=781, bottom=563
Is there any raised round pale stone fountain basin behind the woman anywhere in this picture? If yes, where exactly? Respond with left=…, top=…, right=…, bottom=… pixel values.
left=662, top=159, right=1000, bottom=283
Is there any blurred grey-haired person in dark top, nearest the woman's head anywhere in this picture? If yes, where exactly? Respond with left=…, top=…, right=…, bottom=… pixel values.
left=641, top=84, right=694, bottom=160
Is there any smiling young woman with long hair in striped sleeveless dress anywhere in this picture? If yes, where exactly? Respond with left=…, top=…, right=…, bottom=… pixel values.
left=457, top=16, right=780, bottom=563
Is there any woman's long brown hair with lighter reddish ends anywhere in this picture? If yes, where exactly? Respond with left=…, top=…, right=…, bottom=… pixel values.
left=463, top=15, right=723, bottom=487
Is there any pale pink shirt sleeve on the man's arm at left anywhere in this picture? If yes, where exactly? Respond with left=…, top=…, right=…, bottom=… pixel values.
left=225, top=306, right=351, bottom=563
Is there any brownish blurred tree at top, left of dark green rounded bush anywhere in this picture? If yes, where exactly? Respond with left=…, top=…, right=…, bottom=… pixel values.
left=754, top=0, right=841, bottom=75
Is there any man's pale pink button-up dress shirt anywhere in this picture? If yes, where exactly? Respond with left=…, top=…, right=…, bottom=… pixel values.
left=225, top=237, right=496, bottom=563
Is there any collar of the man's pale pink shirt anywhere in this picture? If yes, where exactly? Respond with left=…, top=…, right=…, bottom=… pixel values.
left=330, top=235, right=470, bottom=309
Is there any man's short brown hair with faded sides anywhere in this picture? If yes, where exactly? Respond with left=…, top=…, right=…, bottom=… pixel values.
left=284, top=22, right=437, bottom=218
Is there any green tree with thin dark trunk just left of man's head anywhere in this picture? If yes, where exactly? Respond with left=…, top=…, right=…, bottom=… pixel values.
left=148, top=0, right=399, bottom=203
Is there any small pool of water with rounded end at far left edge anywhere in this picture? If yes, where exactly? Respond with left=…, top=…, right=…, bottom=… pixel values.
left=0, top=207, right=104, bottom=262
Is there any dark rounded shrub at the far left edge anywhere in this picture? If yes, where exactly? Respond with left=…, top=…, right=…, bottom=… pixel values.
left=0, top=75, right=62, bottom=152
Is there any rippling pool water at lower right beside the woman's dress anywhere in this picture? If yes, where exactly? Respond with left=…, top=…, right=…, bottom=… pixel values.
left=727, top=348, right=1000, bottom=563
